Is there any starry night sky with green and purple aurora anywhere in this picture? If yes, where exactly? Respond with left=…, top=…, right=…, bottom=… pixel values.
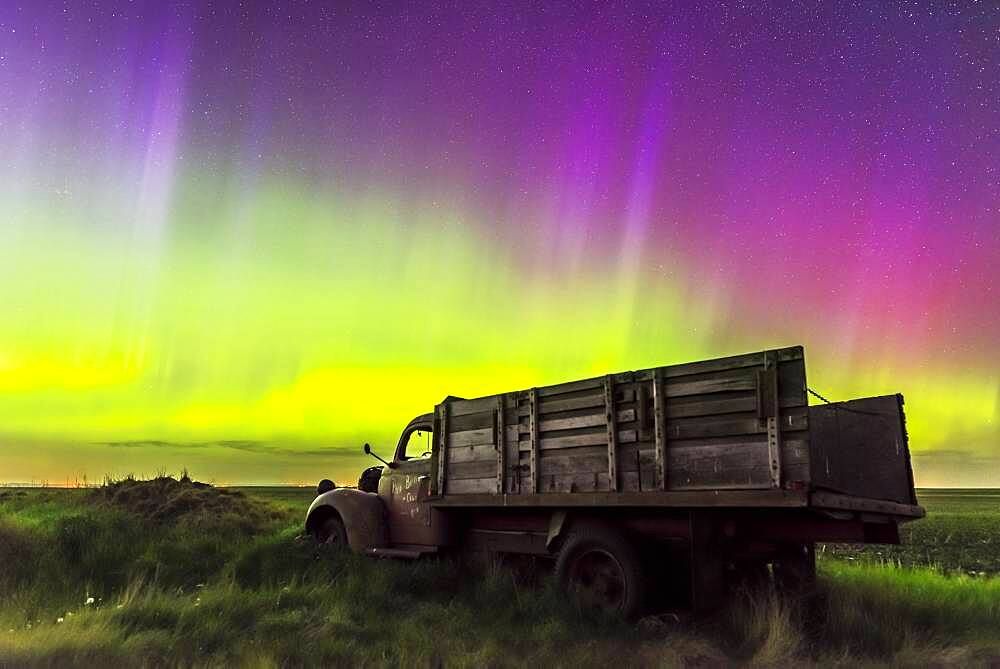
left=0, top=0, right=1000, bottom=486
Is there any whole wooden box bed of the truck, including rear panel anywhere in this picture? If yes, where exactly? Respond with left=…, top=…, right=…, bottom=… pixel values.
left=431, top=346, right=922, bottom=517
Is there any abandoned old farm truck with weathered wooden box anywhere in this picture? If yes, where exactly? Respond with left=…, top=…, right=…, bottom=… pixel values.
left=306, top=346, right=924, bottom=616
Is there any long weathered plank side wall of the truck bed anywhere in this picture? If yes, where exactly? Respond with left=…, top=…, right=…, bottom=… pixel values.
left=435, top=347, right=811, bottom=496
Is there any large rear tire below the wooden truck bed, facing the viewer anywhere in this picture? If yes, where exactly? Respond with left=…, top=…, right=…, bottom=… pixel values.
left=556, top=526, right=646, bottom=619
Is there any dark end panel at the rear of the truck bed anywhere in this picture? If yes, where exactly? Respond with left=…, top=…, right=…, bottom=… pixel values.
left=809, top=395, right=917, bottom=505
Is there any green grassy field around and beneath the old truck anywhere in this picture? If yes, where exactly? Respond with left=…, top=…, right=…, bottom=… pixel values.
left=0, top=480, right=1000, bottom=667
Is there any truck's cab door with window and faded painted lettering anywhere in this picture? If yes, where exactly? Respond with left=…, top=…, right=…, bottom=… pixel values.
left=379, top=416, right=436, bottom=546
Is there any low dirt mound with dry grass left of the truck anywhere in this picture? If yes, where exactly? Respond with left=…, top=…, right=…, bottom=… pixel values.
left=91, top=476, right=276, bottom=525
